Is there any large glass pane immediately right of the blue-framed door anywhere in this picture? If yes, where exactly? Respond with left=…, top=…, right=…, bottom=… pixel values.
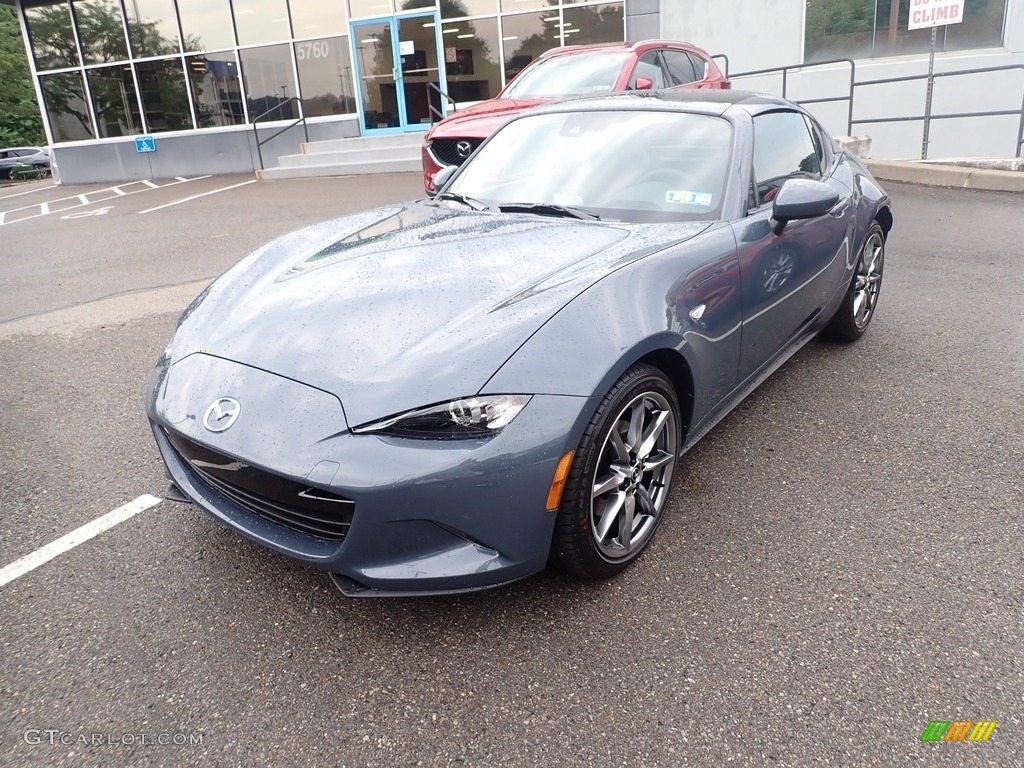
left=441, top=18, right=508, bottom=102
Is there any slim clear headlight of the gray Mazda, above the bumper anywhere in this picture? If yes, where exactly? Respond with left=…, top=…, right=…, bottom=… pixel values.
left=352, top=394, right=530, bottom=440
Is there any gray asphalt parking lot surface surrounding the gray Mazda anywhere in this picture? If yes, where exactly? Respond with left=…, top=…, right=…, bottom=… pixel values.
left=0, top=174, right=1024, bottom=768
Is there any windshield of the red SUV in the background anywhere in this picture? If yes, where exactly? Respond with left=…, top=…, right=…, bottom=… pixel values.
left=502, top=50, right=630, bottom=98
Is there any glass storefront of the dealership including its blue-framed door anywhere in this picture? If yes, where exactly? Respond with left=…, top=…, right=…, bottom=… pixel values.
left=23, top=0, right=625, bottom=142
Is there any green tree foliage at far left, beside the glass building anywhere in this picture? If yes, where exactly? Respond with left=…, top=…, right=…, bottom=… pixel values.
left=0, top=5, right=46, bottom=146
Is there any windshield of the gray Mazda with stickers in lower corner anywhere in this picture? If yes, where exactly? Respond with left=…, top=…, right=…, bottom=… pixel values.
left=445, top=110, right=732, bottom=222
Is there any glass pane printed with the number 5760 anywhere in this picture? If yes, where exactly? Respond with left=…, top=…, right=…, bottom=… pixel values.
left=295, top=37, right=356, bottom=118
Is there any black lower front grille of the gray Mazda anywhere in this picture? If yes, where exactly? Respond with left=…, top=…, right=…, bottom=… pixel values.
left=164, top=430, right=355, bottom=542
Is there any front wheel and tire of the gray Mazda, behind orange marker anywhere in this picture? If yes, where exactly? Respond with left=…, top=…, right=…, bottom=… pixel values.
left=551, top=365, right=680, bottom=579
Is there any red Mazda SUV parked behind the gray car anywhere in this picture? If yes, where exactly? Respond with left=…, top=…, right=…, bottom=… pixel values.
left=422, top=40, right=730, bottom=193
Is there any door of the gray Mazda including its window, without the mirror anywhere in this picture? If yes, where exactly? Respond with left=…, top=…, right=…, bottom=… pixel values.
left=734, top=110, right=854, bottom=381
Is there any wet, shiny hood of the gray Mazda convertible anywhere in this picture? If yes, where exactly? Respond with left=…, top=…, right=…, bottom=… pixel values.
left=171, top=201, right=709, bottom=426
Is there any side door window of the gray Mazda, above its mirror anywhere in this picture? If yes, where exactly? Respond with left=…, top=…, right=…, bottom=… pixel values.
left=754, top=112, right=821, bottom=205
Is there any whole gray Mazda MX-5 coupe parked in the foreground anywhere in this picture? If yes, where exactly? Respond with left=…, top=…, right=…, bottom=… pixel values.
left=148, top=91, right=893, bottom=596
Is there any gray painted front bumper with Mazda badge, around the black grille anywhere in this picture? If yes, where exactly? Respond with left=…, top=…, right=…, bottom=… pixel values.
left=148, top=355, right=596, bottom=596
